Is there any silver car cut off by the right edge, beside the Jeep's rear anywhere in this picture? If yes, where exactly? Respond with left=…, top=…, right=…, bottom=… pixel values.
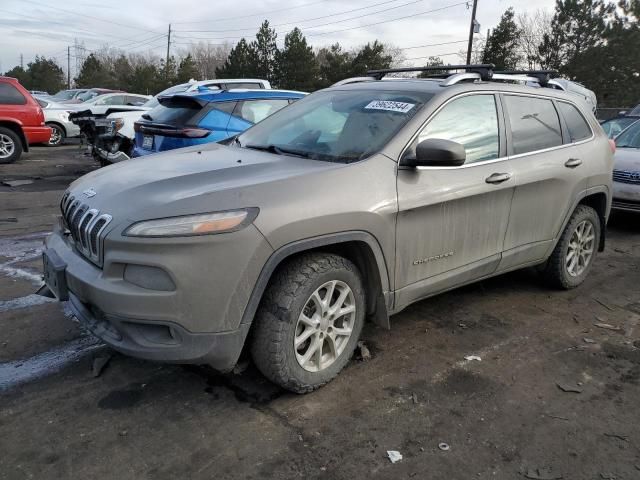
left=613, top=121, right=640, bottom=213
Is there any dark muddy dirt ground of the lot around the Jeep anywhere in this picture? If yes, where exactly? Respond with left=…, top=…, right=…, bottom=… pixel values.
left=0, top=146, right=640, bottom=479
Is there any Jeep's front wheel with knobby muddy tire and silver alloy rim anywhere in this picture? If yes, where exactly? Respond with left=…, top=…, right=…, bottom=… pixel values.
left=251, top=253, right=365, bottom=393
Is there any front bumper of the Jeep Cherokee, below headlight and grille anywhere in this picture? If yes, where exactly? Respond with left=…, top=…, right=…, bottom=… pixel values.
left=46, top=222, right=270, bottom=371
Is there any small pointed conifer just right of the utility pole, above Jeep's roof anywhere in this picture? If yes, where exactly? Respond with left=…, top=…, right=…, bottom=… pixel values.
left=482, top=7, right=521, bottom=70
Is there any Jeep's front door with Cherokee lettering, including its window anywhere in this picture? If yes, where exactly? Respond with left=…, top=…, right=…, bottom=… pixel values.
left=396, top=93, right=515, bottom=308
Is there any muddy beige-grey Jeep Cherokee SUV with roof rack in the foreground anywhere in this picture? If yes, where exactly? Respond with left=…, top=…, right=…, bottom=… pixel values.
left=44, top=65, right=612, bottom=392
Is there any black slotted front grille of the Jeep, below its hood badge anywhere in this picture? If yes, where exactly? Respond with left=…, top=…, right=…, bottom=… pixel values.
left=60, top=193, right=111, bottom=266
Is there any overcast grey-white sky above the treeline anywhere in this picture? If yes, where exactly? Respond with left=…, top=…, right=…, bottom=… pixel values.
left=0, top=0, right=555, bottom=72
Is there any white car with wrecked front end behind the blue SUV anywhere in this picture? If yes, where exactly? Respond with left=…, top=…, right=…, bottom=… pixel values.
left=94, top=78, right=271, bottom=163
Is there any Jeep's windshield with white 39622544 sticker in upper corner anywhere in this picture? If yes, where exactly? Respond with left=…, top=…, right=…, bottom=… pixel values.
left=238, top=90, right=433, bottom=162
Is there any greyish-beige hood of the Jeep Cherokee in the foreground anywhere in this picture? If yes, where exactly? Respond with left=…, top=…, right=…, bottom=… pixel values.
left=69, top=144, right=345, bottom=225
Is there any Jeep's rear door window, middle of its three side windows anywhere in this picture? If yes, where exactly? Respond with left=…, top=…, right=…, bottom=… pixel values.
left=504, top=95, right=562, bottom=155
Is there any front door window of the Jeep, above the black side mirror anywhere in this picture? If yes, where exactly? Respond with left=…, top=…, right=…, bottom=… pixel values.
left=418, top=95, right=500, bottom=163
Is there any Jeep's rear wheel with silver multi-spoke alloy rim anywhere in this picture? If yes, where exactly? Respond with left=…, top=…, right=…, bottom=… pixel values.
left=542, top=205, right=601, bottom=290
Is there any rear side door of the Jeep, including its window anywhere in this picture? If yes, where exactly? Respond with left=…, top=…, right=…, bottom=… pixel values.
left=500, top=94, right=592, bottom=270
